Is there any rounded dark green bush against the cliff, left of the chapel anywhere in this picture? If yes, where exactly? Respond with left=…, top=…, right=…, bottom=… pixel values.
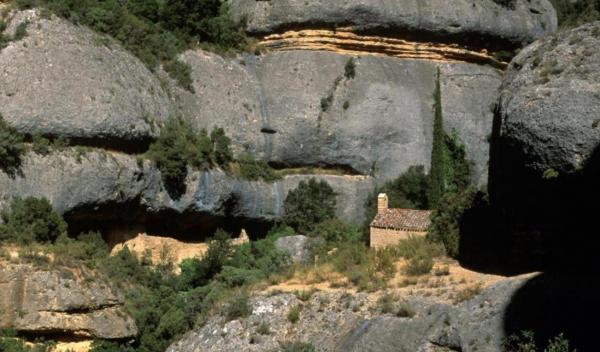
left=283, top=178, right=337, bottom=234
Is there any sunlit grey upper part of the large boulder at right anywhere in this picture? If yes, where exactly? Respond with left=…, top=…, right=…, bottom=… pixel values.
left=499, top=22, right=600, bottom=177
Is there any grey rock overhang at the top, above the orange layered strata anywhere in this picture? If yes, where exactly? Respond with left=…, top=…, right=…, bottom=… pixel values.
left=230, top=0, right=557, bottom=45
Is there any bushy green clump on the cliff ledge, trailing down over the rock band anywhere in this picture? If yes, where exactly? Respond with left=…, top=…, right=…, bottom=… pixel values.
left=146, top=117, right=233, bottom=197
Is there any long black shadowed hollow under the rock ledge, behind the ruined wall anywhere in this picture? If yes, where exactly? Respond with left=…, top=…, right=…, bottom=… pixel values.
left=64, top=201, right=272, bottom=244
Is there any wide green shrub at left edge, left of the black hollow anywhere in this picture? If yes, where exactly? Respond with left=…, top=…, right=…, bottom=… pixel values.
left=0, top=197, right=67, bottom=244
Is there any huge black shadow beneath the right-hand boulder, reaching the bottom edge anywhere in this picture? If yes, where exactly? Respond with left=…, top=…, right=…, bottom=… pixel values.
left=460, top=106, right=600, bottom=352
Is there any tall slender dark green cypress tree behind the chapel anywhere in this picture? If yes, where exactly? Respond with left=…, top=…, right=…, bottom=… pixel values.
left=429, top=67, right=445, bottom=208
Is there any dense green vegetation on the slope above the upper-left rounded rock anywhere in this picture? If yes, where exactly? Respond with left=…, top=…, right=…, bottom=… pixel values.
left=17, top=0, right=247, bottom=89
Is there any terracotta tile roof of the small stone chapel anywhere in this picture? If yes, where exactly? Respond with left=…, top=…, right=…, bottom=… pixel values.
left=371, top=209, right=431, bottom=231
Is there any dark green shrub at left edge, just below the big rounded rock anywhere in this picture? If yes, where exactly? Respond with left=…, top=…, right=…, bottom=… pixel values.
left=0, top=115, right=26, bottom=176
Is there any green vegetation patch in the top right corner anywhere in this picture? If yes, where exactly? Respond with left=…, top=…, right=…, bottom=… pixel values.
left=550, top=0, right=600, bottom=28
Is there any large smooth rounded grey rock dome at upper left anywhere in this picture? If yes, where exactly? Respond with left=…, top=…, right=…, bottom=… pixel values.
left=0, top=10, right=172, bottom=146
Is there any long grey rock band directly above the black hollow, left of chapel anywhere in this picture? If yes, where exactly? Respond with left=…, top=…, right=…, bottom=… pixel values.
left=0, top=150, right=373, bottom=221
